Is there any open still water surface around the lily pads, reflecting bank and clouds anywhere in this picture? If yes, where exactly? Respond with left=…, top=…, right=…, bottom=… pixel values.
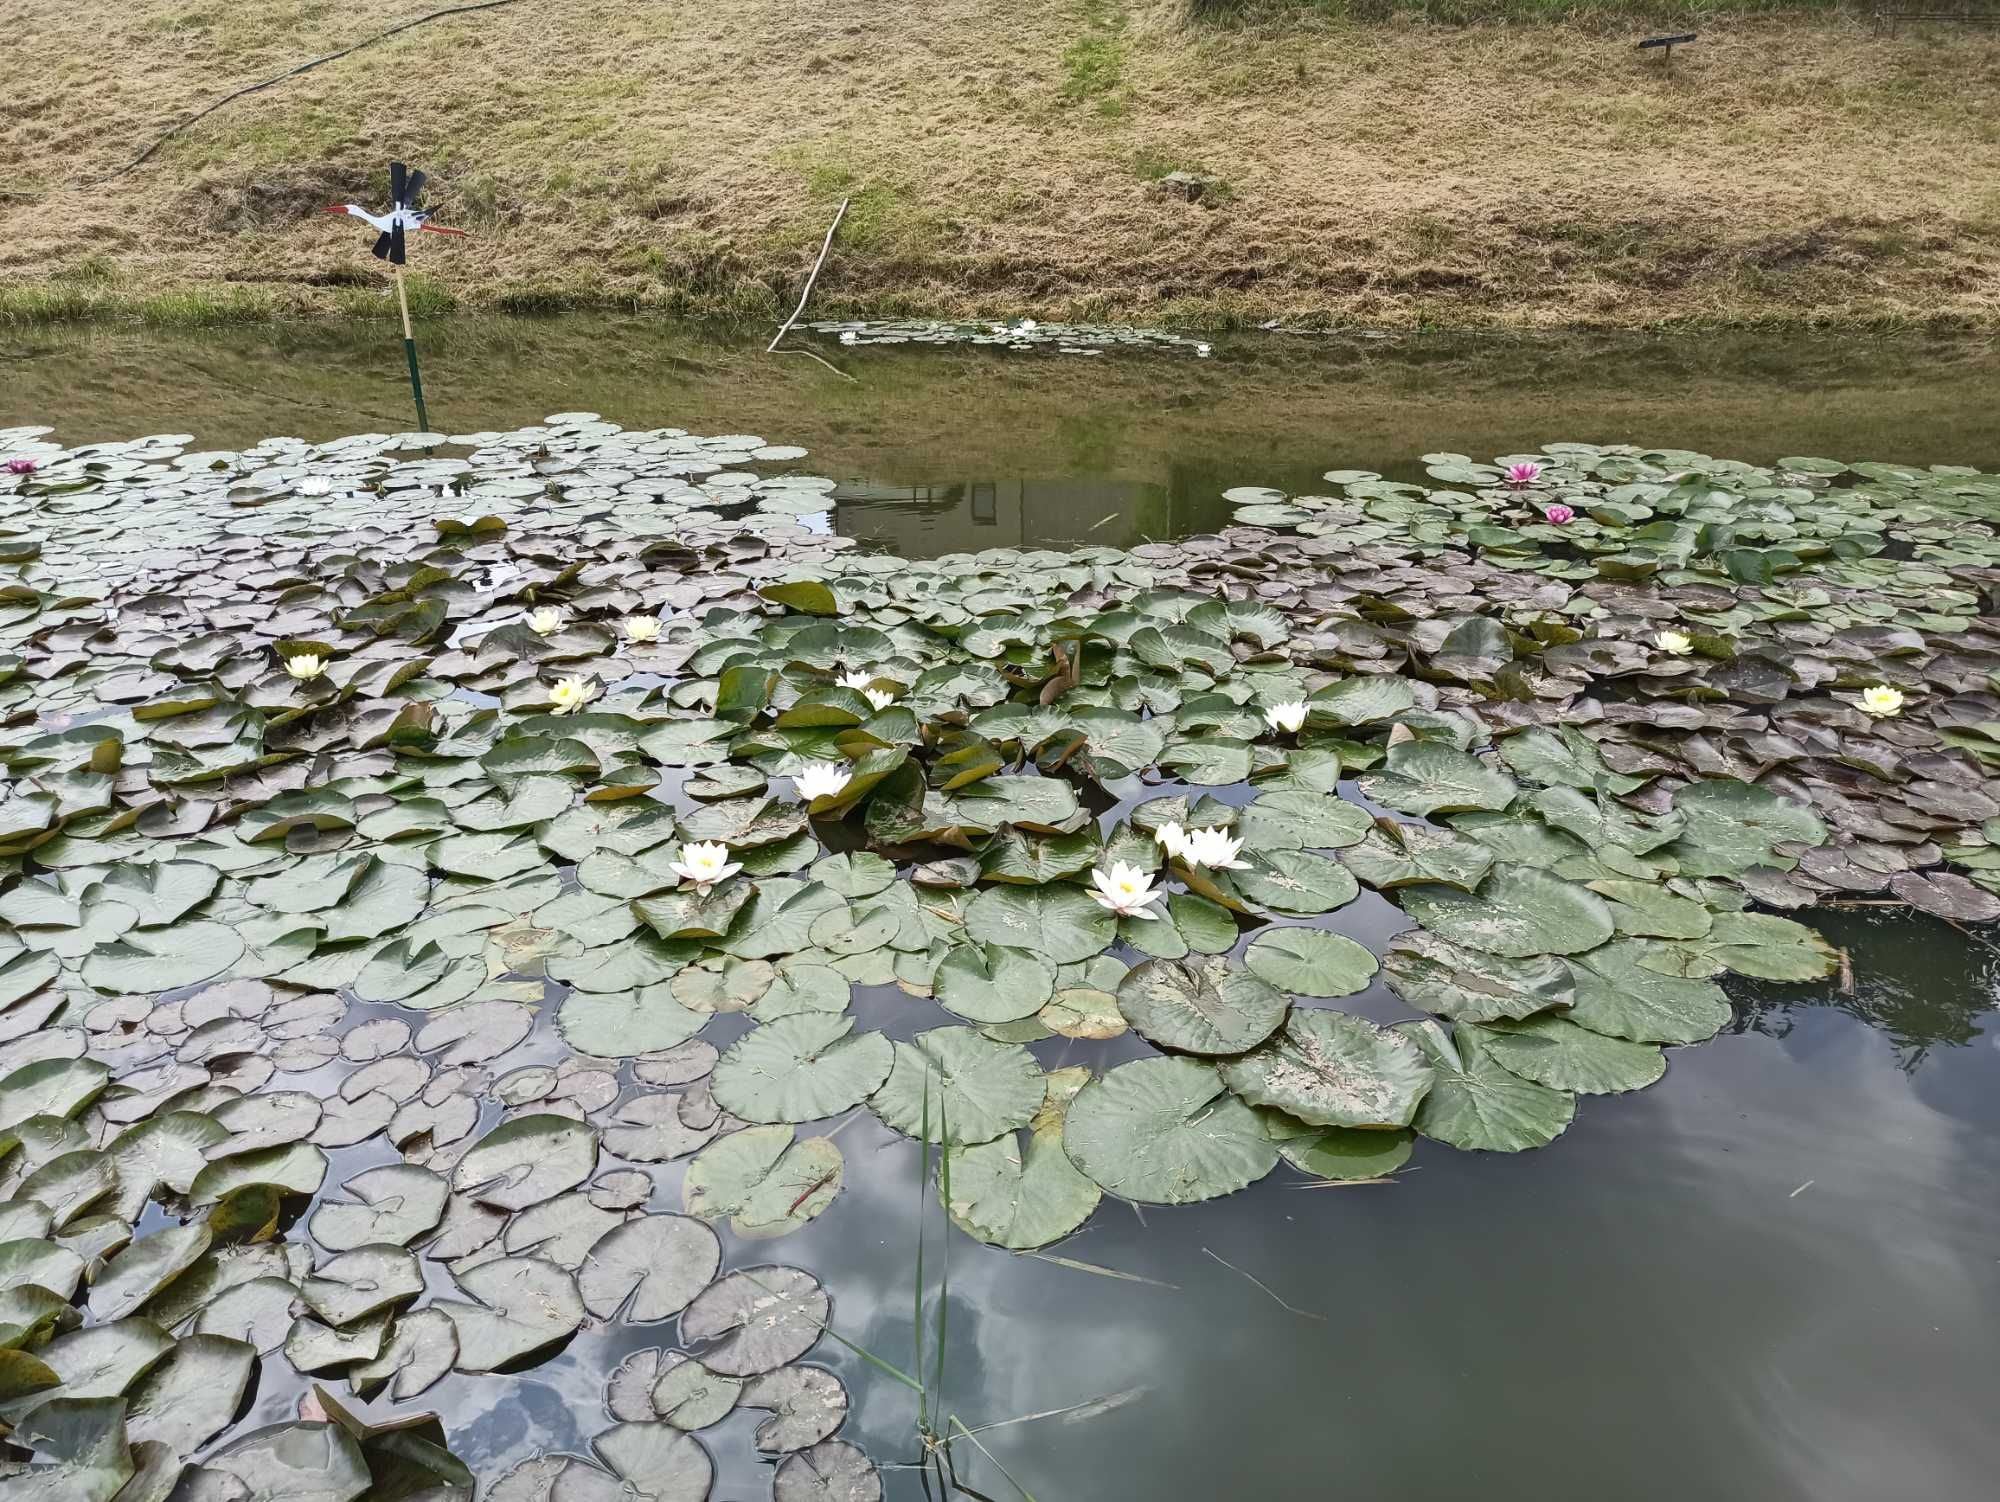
left=0, top=320, right=2000, bottom=1502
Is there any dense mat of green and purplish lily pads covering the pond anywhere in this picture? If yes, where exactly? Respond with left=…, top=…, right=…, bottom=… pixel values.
left=0, top=414, right=2000, bottom=1502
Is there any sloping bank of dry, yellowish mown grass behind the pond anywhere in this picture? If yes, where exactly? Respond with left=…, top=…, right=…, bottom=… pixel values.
left=0, top=0, right=2000, bottom=326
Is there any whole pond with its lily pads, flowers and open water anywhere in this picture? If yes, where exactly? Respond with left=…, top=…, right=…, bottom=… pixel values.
left=0, top=318, right=2000, bottom=1502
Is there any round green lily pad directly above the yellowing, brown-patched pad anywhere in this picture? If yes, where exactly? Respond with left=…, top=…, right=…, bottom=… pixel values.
left=712, top=1012, right=894, bottom=1122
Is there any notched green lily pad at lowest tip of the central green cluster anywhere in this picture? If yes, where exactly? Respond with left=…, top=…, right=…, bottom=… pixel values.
left=944, top=1068, right=1102, bottom=1248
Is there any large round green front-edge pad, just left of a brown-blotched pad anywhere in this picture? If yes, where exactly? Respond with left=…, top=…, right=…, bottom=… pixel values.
left=1062, top=1058, right=1278, bottom=1204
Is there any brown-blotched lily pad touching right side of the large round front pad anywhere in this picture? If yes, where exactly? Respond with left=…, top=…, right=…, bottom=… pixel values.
left=1218, top=1008, right=1432, bottom=1128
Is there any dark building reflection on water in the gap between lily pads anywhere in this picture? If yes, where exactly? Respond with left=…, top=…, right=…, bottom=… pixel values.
left=834, top=478, right=1174, bottom=558
